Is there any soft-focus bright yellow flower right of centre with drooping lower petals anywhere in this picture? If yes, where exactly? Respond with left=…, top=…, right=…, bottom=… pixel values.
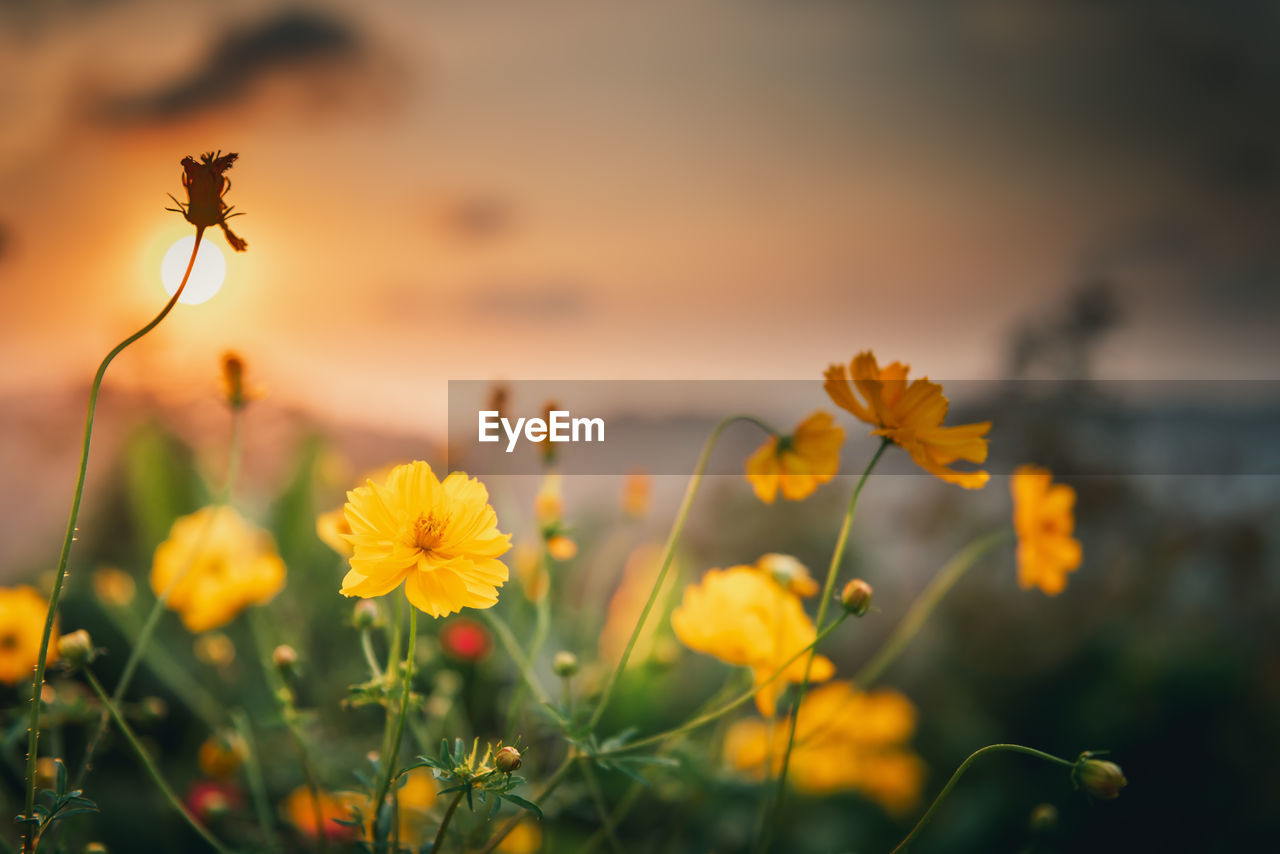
left=671, top=566, right=836, bottom=717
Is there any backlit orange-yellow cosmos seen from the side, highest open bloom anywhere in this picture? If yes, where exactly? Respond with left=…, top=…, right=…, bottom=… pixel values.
left=823, top=351, right=991, bottom=489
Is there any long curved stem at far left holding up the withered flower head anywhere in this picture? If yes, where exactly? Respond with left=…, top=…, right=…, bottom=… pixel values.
left=23, top=227, right=205, bottom=853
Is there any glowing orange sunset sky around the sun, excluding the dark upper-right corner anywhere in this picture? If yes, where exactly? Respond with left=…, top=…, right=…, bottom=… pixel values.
left=0, top=1, right=1274, bottom=428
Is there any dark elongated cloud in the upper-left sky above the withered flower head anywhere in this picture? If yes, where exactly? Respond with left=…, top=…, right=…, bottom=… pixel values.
left=105, top=10, right=364, bottom=122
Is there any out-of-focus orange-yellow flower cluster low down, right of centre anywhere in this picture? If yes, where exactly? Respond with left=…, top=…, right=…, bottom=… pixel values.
left=724, top=681, right=924, bottom=816
